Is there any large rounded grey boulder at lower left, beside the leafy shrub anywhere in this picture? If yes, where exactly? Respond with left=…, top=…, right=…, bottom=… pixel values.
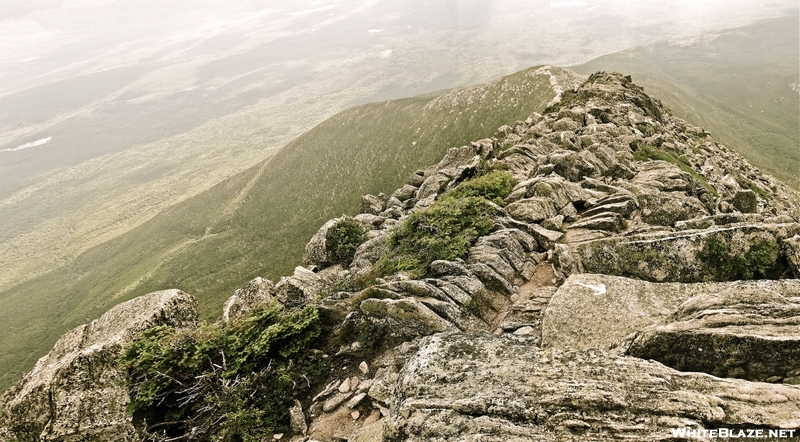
left=0, top=290, right=197, bottom=442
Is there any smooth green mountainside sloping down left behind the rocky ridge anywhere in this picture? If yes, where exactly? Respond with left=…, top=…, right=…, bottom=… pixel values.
left=0, top=68, right=578, bottom=388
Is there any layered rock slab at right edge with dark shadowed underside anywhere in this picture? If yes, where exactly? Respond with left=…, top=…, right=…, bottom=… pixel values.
left=628, top=280, right=800, bottom=382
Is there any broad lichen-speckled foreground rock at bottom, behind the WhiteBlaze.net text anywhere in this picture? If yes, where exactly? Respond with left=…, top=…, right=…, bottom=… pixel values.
left=383, top=333, right=800, bottom=442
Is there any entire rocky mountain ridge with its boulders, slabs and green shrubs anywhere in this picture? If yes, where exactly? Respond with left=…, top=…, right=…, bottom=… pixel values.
left=0, top=72, right=800, bottom=442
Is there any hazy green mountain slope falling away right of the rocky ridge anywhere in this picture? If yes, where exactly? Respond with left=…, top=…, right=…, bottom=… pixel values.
left=572, top=11, right=800, bottom=189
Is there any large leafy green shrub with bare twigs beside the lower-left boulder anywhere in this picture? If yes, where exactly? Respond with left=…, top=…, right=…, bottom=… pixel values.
left=122, top=306, right=325, bottom=441
